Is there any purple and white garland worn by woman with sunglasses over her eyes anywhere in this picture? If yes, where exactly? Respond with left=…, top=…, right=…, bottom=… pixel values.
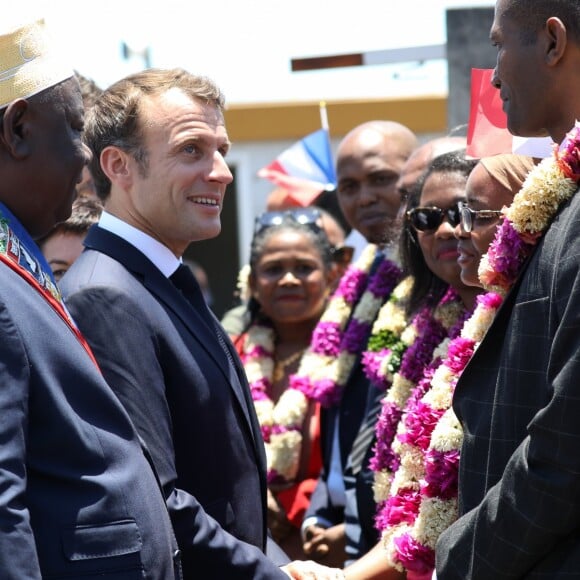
left=369, top=288, right=465, bottom=504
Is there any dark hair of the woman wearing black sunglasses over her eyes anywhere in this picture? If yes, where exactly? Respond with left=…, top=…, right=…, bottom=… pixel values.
left=400, top=149, right=477, bottom=314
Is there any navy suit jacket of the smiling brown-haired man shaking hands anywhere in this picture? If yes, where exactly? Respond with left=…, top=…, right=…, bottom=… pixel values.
left=62, top=226, right=287, bottom=579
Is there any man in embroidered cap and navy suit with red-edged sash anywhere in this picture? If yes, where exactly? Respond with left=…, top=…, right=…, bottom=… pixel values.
left=0, top=21, right=180, bottom=580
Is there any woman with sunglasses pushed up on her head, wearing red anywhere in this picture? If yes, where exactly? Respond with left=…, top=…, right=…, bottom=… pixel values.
left=232, top=208, right=336, bottom=559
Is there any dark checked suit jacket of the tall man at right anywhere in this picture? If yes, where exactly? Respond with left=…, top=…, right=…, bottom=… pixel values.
left=437, top=193, right=580, bottom=580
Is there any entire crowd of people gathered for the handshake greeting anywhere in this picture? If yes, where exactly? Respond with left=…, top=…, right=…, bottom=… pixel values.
left=0, top=0, right=580, bottom=580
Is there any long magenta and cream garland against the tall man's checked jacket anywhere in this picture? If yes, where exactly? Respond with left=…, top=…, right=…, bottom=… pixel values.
left=378, top=122, right=580, bottom=573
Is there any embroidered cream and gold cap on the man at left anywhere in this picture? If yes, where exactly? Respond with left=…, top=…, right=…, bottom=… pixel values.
left=0, top=18, right=74, bottom=109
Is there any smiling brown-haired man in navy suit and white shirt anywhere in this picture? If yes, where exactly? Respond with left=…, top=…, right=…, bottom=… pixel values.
left=62, top=69, right=334, bottom=580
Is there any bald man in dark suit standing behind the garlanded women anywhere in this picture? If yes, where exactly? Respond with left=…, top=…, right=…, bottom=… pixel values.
left=302, top=121, right=417, bottom=565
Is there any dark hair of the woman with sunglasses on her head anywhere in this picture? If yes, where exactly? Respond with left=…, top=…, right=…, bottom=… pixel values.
left=244, top=211, right=333, bottom=332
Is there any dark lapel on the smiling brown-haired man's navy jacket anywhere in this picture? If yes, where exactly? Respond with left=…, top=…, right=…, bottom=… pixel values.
left=84, top=226, right=258, bottom=444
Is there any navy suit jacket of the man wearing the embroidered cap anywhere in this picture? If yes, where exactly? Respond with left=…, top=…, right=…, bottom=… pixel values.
left=0, top=263, right=178, bottom=580
